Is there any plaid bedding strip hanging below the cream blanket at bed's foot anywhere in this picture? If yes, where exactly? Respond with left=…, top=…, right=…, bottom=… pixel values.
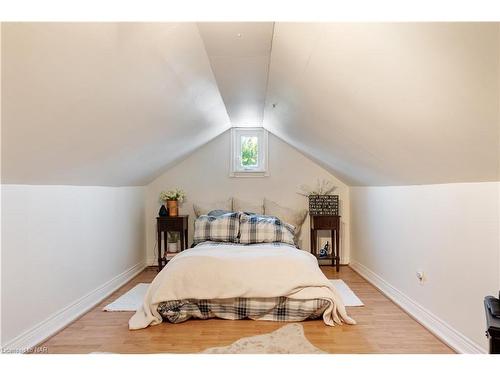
left=158, top=297, right=329, bottom=323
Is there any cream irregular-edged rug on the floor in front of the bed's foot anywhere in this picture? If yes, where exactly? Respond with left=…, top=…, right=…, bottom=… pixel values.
left=201, top=323, right=326, bottom=354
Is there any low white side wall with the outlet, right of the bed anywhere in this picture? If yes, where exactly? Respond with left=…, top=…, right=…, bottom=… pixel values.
left=351, top=182, right=500, bottom=354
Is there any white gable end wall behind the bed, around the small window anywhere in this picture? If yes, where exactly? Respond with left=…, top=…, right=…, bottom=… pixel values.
left=146, top=131, right=350, bottom=263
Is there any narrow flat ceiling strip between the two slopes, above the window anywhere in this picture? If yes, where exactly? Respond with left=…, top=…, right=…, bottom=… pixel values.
left=198, top=22, right=273, bottom=126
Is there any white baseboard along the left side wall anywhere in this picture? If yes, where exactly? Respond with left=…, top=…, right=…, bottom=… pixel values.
left=2, top=261, right=146, bottom=353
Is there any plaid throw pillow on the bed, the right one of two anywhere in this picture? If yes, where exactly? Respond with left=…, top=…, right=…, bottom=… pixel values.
left=240, top=213, right=295, bottom=246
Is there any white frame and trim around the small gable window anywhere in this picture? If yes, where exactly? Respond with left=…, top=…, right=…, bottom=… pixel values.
left=229, top=127, right=269, bottom=177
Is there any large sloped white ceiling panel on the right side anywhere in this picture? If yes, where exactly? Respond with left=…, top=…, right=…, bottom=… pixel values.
left=264, top=23, right=500, bottom=185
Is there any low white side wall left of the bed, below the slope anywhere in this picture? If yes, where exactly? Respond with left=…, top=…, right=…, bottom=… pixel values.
left=2, top=185, right=145, bottom=346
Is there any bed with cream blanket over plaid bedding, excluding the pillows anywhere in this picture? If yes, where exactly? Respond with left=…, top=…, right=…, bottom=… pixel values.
left=129, top=234, right=355, bottom=330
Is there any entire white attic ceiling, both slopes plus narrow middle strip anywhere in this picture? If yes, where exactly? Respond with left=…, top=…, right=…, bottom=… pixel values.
left=1, top=23, right=500, bottom=186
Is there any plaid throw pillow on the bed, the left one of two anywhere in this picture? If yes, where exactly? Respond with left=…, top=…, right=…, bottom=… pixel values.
left=193, top=212, right=240, bottom=244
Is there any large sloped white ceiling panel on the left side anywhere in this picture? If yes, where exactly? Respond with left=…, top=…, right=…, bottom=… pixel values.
left=2, top=23, right=230, bottom=186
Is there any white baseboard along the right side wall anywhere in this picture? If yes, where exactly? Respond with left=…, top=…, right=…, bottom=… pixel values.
left=349, top=259, right=487, bottom=354
